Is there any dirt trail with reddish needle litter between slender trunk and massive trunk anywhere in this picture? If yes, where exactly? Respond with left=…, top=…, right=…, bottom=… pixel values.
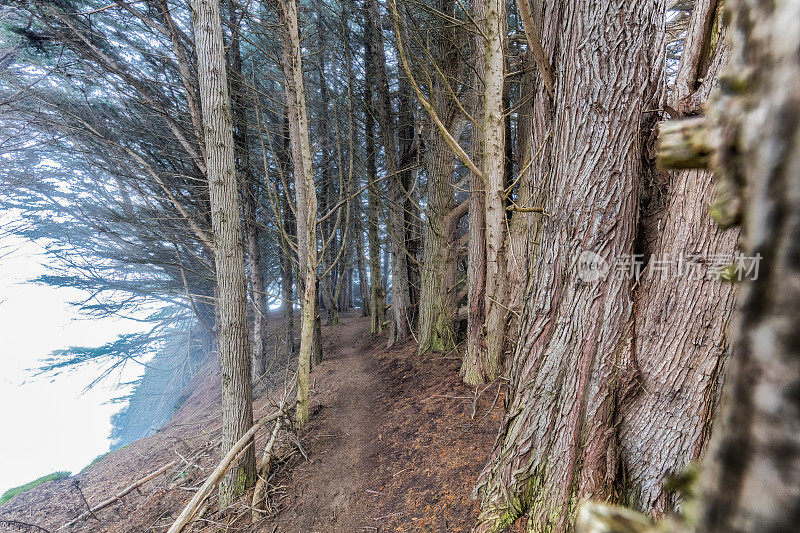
left=272, top=316, right=503, bottom=533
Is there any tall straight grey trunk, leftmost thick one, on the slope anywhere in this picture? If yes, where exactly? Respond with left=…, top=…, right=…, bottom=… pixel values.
left=192, top=0, right=255, bottom=507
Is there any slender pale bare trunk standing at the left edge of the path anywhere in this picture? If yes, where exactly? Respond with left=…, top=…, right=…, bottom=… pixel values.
left=279, top=0, right=321, bottom=427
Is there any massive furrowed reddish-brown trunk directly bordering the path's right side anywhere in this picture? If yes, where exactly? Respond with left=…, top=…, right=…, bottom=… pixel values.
left=478, top=0, right=664, bottom=531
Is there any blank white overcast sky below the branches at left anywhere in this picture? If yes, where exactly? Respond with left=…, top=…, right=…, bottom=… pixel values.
left=0, top=233, right=142, bottom=494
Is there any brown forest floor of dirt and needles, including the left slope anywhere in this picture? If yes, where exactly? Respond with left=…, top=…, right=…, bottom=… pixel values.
left=0, top=314, right=504, bottom=533
